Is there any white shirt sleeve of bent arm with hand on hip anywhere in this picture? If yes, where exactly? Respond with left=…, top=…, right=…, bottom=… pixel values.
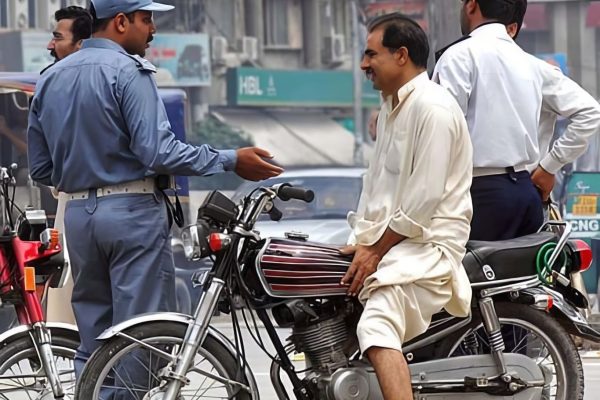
left=527, top=56, right=600, bottom=174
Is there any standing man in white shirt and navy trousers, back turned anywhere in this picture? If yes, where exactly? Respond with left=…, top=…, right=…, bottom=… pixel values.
left=433, top=0, right=544, bottom=240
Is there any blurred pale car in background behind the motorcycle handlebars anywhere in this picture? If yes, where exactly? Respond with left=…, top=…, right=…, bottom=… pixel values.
left=233, top=168, right=365, bottom=245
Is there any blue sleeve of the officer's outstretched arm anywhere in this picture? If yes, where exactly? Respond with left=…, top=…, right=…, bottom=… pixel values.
left=121, top=70, right=237, bottom=175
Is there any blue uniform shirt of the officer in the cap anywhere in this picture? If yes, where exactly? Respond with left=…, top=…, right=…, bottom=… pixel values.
left=27, top=39, right=237, bottom=192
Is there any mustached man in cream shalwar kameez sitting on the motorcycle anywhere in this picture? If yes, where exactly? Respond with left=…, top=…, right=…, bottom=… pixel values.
left=342, top=14, right=473, bottom=400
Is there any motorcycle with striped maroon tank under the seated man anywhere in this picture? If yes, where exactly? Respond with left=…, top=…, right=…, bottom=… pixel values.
left=76, top=184, right=600, bottom=400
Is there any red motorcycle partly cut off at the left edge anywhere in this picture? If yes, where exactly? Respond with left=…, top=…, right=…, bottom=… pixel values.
left=0, top=164, right=79, bottom=400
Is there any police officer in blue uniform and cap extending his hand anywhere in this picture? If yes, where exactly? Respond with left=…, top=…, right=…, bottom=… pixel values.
left=28, top=0, right=282, bottom=372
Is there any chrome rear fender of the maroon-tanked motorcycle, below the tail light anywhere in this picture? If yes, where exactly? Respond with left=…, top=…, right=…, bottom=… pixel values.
left=520, top=286, right=600, bottom=343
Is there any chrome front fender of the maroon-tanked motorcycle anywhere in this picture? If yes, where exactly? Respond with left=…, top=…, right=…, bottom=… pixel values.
left=96, top=312, right=258, bottom=395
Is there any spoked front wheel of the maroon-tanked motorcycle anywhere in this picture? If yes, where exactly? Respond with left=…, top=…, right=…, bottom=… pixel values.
left=77, top=322, right=252, bottom=400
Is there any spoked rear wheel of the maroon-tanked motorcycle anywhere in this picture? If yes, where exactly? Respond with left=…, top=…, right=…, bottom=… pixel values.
left=444, top=303, right=584, bottom=400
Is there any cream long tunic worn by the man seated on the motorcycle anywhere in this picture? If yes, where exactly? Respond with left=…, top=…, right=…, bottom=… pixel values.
left=349, top=72, right=473, bottom=315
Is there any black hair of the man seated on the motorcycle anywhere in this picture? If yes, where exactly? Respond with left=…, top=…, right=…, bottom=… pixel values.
left=367, top=13, right=429, bottom=68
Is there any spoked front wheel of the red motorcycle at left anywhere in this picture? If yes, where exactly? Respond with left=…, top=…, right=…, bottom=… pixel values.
left=0, top=333, right=79, bottom=400
